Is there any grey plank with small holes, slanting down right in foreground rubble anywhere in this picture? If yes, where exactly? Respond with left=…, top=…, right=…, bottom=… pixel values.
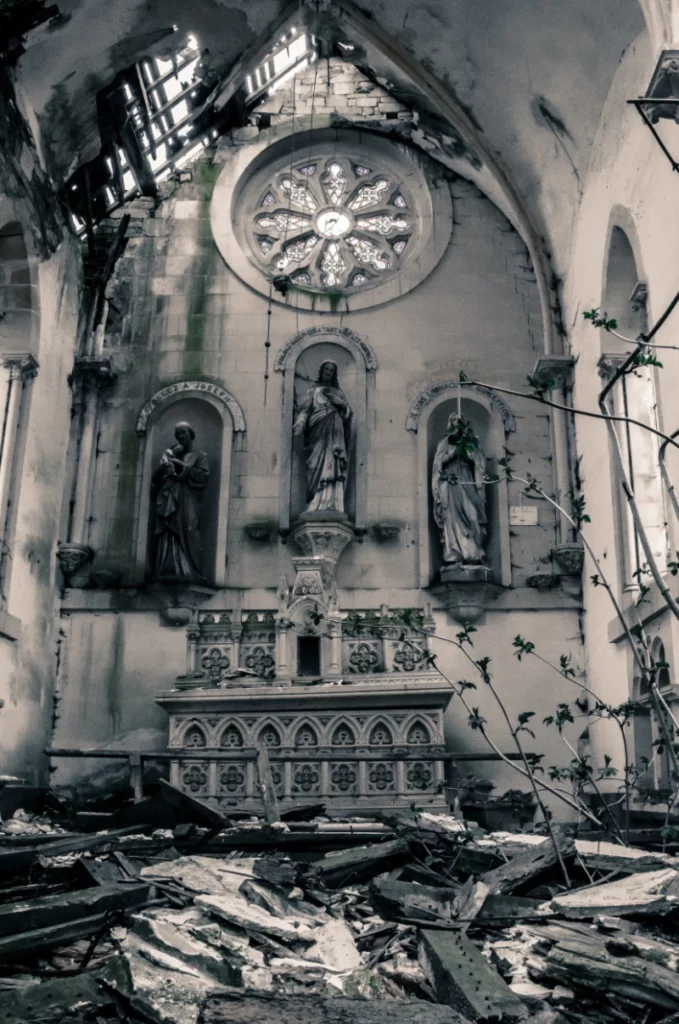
left=418, top=928, right=527, bottom=1020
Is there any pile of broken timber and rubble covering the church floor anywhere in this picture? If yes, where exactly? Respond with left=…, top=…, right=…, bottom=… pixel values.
left=0, top=786, right=679, bottom=1024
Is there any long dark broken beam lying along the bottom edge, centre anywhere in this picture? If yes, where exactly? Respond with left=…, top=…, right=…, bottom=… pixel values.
left=202, top=990, right=467, bottom=1024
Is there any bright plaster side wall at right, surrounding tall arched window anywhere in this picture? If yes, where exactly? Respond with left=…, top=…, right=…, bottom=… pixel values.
left=563, top=28, right=679, bottom=778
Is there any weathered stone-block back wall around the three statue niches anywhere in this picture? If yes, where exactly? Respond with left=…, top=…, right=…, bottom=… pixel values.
left=53, top=125, right=580, bottom=806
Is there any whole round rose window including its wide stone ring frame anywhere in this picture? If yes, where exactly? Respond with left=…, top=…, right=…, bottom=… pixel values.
left=218, top=128, right=453, bottom=312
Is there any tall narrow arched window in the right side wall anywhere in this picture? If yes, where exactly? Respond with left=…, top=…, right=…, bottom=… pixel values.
left=601, top=227, right=668, bottom=588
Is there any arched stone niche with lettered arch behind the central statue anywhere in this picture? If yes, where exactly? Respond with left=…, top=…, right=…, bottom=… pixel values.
left=274, top=328, right=377, bottom=536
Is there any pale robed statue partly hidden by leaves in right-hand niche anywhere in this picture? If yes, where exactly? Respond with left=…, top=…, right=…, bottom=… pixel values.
left=431, top=413, right=487, bottom=566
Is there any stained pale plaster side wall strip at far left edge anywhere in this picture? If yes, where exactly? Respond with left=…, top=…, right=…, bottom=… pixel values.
left=0, top=242, right=79, bottom=785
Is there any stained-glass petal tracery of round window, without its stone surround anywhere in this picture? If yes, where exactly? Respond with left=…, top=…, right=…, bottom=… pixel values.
left=252, top=157, right=414, bottom=292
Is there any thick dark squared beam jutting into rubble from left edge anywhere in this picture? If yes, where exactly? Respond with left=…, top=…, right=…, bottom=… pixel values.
left=0, top=882, right=151, bottom=938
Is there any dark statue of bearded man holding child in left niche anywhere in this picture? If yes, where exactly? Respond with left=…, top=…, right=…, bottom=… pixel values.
left=153, top=423, right=210, bottom=582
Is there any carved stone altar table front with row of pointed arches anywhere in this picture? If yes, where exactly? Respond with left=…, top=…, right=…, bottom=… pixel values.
left=157, top=673, right=451, bottom=812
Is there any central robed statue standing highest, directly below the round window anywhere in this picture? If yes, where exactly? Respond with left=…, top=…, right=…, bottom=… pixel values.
left=293, top=359, right=351, bottom=520
